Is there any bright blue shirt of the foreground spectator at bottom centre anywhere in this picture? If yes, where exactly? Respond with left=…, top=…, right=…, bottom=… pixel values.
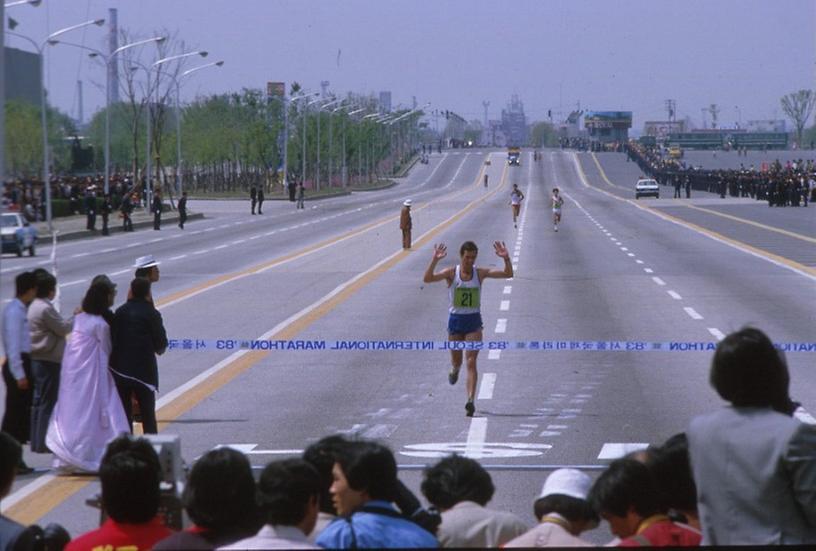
left=315, top=500, right=439, bottom=549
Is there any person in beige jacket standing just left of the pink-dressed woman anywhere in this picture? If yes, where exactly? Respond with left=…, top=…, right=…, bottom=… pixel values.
left=28, top=269, right=74, bottom=453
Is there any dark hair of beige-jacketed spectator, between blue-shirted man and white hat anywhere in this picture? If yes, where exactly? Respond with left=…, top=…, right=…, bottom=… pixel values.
left=420, top=455, right=496, bottom=511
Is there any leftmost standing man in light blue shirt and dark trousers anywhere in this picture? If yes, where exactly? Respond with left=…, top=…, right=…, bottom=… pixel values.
left=0, top=272, right=37, bottom=474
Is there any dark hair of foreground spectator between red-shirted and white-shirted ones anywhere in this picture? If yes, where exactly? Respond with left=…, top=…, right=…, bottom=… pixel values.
left=181, top=447, right=260, bottom=539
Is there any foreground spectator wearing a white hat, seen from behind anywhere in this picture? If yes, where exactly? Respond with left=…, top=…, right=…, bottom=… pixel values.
left=504, top=469, right=600, bottom=547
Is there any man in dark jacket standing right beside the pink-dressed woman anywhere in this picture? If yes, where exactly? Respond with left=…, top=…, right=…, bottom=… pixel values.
left=110, top=277, right=167, bottom=434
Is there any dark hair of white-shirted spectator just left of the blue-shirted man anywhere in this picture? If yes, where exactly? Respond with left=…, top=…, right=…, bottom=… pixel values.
left=258, top=459, right=322, bottom=526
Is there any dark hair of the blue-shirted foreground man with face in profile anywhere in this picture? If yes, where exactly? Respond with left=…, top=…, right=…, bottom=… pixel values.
left=337, top=440, right=397, bottom=501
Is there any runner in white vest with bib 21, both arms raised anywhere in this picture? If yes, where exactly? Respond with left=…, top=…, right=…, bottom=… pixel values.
left=423, top=241, right=513, bottom=417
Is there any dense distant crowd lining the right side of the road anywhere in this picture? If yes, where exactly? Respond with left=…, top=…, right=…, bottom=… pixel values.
left=626, top=141, right=816, bottom=207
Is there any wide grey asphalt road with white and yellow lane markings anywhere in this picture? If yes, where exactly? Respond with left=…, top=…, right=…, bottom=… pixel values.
left=0, top=151, right=816, bottom=543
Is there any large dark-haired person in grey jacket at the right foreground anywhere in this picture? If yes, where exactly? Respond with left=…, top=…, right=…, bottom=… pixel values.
left=688, top=327, right=816, bottom=545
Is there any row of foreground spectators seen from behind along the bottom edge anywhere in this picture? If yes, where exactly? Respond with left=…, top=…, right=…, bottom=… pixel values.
left=0, top=328, right=816, bottom=551
